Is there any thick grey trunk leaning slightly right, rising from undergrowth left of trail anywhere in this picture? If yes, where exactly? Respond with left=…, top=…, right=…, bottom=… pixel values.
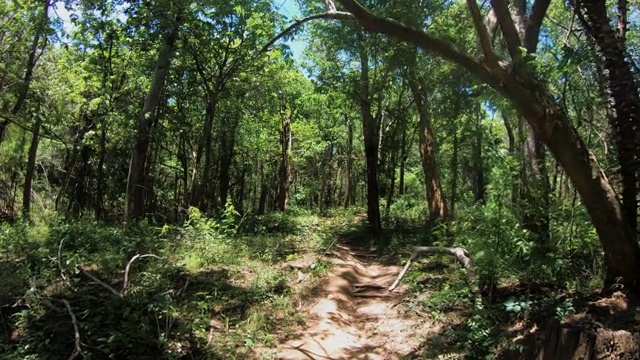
left=125, top=24, right=180, bottom=220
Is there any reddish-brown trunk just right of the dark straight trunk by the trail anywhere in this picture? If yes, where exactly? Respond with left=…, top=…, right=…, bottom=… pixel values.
left=409, top=52, right=448, bottom=224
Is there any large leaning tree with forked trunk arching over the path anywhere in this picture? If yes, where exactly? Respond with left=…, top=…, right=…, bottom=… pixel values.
left=330, top=0, right=640, bottom=289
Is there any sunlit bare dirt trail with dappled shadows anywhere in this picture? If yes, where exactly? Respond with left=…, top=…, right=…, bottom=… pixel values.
left=262, top=245, right=439, bottom=360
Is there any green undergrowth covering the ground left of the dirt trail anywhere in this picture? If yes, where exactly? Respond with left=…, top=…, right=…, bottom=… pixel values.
left=0, top=206, right=340, bottom=359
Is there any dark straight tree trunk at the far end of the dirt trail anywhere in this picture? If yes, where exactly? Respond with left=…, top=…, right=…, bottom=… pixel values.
left=358, top=44, right=382, bottom=235
